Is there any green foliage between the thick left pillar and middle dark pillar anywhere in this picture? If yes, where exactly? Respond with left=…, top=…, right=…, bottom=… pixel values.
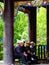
left=14, top=11, right=28, bottom=43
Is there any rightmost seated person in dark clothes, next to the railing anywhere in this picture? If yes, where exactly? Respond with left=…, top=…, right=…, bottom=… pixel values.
left=30, top=41, right=38, bottom=64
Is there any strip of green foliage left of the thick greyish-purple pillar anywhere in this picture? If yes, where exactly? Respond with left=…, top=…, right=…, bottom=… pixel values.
left=0, top=18, right=4, bottom=60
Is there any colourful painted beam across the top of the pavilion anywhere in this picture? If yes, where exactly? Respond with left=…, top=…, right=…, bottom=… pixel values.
left=0, top=0, right=49, bottom=6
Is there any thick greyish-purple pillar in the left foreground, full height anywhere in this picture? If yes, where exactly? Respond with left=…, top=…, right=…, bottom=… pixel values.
left=4, top=0, right=14, bottom=65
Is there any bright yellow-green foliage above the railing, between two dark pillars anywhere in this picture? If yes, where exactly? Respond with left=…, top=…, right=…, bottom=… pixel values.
left=37, top=7, right=47, bottom=45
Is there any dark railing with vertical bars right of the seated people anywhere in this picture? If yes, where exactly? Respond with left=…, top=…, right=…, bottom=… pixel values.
left=35, top=45, right=47, bottom=59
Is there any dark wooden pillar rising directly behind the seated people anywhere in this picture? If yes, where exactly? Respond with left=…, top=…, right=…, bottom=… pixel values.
left=29, top=7, right=36, bottom=43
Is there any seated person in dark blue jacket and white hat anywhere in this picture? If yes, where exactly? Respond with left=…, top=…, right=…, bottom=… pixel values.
left=14, top=41, right=27, bottom=65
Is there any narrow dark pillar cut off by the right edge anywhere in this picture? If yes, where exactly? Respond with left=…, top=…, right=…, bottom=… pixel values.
left=47, top=6, right=49, bottom=62
